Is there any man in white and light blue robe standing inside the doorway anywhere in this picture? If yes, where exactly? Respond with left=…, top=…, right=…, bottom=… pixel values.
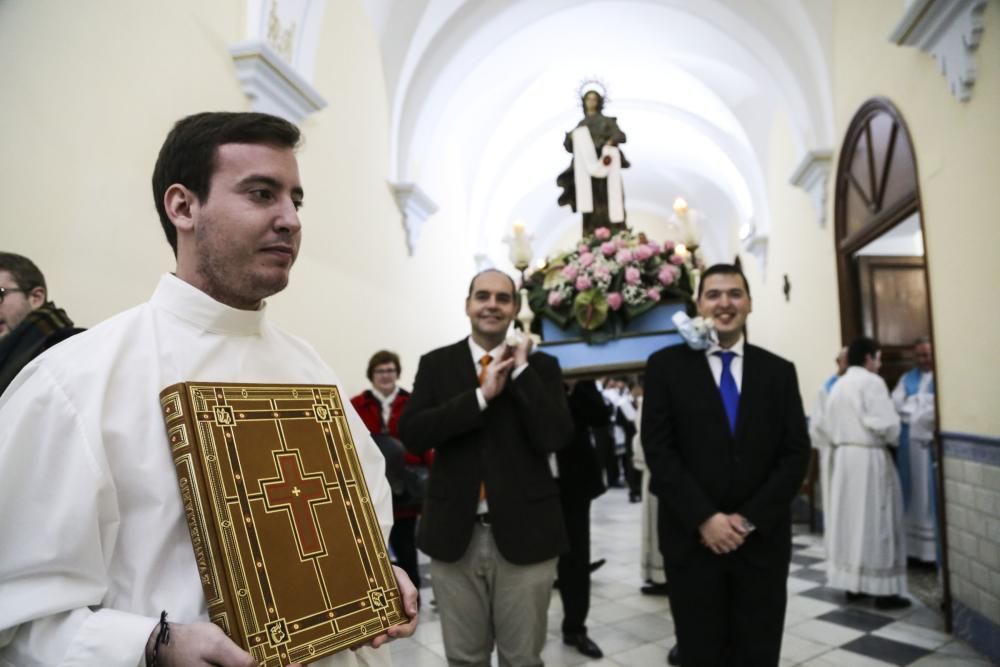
left=892, top=338, right=938, bottom=563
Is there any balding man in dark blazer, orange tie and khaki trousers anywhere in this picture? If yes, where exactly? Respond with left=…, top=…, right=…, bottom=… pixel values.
left=400, top=270, right=573, bottom=666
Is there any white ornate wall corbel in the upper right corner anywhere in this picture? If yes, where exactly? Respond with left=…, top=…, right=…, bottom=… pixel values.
left=889, top=0, right=987, bottom=102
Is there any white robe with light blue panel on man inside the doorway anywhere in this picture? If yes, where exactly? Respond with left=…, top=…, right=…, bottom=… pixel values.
left=892, top=372, right=937, bottom=563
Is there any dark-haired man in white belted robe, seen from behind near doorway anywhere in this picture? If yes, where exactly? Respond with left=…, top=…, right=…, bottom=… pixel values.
left=819, top=338, right=910, bottom=609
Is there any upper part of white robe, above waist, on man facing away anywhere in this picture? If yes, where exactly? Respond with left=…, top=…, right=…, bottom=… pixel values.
left=819, top=366, right=899, bottom=447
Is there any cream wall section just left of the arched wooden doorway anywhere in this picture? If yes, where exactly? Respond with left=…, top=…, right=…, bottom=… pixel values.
left=741, top=115, right=840, bottom=413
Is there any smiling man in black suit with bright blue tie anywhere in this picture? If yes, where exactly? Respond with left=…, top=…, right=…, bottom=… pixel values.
left=642, top=264, right=809, bottom=667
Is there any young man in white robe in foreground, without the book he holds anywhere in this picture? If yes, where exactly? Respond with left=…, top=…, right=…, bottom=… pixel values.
left=0, top=113, right=416, bottom=667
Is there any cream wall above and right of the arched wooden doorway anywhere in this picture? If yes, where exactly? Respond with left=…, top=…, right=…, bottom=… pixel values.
left=833, top=0, right=1000, bottom=436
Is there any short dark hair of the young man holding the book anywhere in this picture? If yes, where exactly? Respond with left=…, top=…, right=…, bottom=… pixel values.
left=153, top=111, right=302, bottom=256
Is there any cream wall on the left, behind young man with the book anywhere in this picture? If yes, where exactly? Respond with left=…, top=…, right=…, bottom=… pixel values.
left=0, top=0, right=468, bottom=393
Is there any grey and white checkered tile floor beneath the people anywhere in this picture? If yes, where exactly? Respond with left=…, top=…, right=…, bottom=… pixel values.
left=390, top=489, right=990, bottom=667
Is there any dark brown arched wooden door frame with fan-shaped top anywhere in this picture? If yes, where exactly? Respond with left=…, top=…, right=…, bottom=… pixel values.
left=834, top=97, right=952, bottom=632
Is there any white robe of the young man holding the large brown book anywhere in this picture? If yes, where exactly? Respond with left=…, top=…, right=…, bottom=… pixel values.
left=0, top=275, right=392, bottom=667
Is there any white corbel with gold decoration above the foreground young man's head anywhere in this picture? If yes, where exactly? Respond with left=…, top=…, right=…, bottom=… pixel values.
left=229, top=0, right=326, bottom=123
